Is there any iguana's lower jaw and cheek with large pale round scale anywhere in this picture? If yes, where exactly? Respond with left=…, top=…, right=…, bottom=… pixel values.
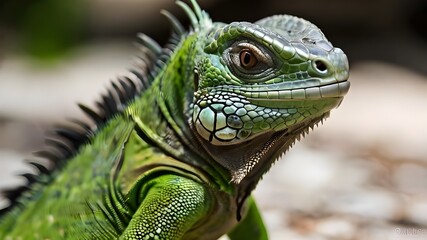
left=192, top=80, right=350, bottom=146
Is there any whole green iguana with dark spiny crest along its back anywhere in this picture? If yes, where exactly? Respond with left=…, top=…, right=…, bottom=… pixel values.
left=0, top=0, right=350, bottom=240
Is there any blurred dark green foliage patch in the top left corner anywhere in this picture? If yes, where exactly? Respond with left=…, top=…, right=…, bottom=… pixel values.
left=0, top=0, right=88, bottom=60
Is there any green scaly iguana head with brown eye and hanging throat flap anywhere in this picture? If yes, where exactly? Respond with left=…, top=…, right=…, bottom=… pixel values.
left=191, top=15, right=350, bottom=183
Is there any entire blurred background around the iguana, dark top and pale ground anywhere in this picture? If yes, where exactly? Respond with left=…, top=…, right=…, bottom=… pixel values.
left=0, top=0, right=427, bottom=240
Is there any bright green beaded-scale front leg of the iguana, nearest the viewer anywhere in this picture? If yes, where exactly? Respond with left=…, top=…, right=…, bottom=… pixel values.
left=120, top=175, right=210, bottom=240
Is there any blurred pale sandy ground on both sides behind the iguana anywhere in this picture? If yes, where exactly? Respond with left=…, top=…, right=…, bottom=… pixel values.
left=0, top=40, right=427, bottom=240
